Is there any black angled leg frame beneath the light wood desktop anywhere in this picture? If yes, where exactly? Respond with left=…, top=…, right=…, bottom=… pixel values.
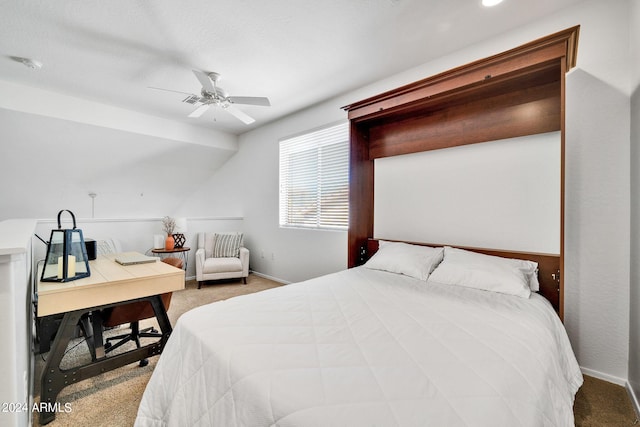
left=40, top=295, right=172, bottom=425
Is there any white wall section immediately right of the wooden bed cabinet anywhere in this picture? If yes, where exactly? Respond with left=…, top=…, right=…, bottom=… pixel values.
left=565, top=2, right=630, bottom=384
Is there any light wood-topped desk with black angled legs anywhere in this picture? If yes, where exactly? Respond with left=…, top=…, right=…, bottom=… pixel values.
left=37, top=254, right=185, bottom=424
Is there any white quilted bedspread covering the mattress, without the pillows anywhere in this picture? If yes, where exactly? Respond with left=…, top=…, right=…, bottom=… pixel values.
left=136, top=267, right=582, bottom=427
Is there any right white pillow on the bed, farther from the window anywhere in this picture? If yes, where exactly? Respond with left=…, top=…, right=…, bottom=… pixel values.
left=429, top=246, right=538, bottom=298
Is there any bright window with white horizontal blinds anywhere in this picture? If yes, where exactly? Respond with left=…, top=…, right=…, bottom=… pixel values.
left=280, top=123, right=349, bottom=230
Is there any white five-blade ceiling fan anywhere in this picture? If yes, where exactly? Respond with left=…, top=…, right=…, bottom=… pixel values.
left=151, top=70, right=271, bottom=124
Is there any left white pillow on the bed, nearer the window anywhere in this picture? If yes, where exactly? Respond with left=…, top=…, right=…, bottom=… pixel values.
left=364, top=240, right=444, bottom=280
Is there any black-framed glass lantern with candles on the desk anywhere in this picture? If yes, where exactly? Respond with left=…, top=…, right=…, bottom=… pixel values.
left=40, top=209, right=91, bottom=282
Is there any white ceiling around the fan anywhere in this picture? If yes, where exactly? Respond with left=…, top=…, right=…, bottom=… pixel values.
left=0, top=0, right=582, bottom=134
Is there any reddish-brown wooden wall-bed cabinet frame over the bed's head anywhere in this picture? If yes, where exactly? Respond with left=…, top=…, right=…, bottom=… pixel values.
left=344, top=26, right=580, bottom=317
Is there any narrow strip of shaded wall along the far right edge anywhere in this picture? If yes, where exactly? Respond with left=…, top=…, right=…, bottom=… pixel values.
left=629, top=1, right=640, bottom=414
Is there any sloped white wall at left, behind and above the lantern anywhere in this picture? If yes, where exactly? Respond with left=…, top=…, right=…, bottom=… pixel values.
left=0, top=88, right=237, bottom=219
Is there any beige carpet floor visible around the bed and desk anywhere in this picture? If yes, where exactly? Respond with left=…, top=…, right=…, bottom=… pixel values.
left=33, top=274, right=636, bottom=427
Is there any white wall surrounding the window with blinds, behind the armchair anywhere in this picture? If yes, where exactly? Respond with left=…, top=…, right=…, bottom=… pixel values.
left=182, top=105, right=347, bottom=282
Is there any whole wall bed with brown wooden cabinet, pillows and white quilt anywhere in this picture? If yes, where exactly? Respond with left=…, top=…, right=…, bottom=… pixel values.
left=136, top=27, right=582, bottom=427
